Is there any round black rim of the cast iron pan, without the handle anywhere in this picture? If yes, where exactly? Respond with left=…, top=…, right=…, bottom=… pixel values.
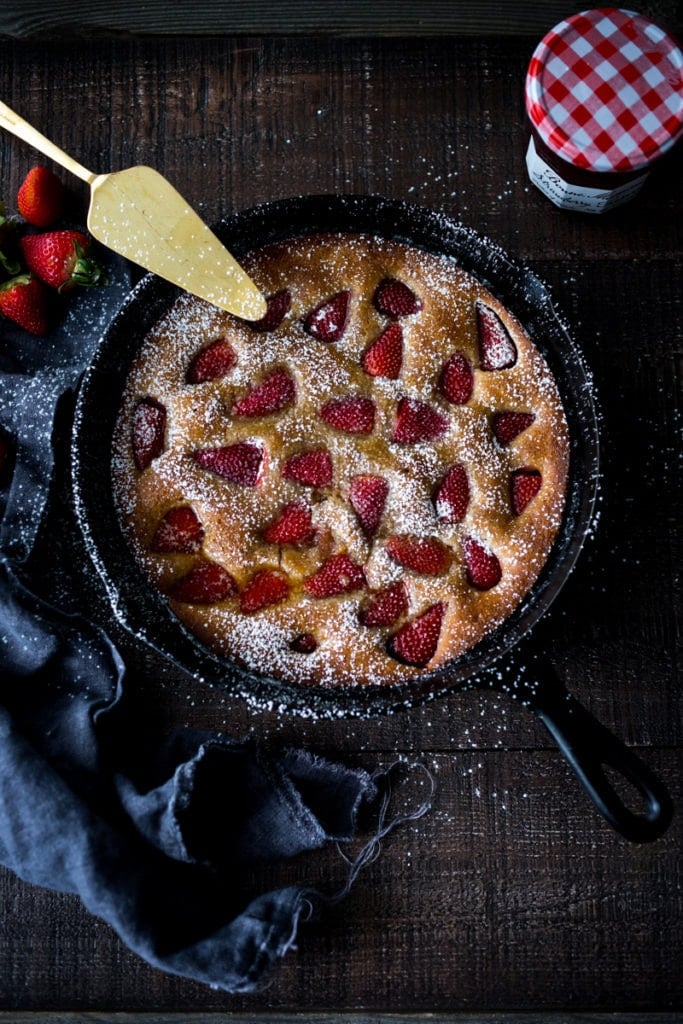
left=72, top=195, right=599, bottom=718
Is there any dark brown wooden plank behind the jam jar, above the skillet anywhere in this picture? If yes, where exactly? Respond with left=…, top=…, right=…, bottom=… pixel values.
left=2, top=38, right=683, bottom=261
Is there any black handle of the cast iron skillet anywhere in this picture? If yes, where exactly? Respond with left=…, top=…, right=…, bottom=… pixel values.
left=529, top=663, right=674, bottom=843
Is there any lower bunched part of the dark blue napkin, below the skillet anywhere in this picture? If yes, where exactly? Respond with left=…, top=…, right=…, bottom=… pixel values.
left=0, top=562, right=378, bottom=992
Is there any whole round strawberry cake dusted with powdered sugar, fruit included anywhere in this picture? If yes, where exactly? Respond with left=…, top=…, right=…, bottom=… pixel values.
left=114, top=233, right=568, bottom=686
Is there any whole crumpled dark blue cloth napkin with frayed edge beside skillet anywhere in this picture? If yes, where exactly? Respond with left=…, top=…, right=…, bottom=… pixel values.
left=0, top=257, right=429, bottom=993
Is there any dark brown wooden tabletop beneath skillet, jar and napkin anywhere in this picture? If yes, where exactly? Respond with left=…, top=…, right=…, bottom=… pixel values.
left=0, top=4, right=683, bottom=1022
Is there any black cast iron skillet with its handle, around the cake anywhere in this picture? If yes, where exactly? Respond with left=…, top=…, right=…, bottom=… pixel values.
left=72, top=196, right=672, bottom=842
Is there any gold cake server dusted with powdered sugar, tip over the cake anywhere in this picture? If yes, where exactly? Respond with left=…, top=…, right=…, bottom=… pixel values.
left=0, top=101, right=266, bottom=321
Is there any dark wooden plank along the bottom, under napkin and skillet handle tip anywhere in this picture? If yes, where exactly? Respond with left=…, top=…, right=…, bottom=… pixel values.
left=0, top=751, right=683, bottom=1013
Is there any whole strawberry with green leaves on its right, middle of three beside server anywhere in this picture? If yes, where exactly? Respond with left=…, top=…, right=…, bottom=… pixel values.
left=19, top=230, right=102, bottom=292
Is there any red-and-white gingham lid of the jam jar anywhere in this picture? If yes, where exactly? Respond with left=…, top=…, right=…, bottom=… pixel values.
left=526, top=7, right=683, bottom=172
